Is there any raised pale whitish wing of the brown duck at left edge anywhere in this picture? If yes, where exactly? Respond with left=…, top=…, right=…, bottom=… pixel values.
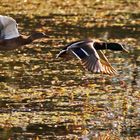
left=0, top=16, right=20, bottom=39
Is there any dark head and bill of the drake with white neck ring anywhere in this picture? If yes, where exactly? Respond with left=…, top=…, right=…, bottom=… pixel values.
left=107, top=43, right=128, bottom=53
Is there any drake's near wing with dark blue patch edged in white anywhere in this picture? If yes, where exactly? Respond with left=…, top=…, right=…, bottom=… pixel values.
left=69, top=41, right=103, bottom=73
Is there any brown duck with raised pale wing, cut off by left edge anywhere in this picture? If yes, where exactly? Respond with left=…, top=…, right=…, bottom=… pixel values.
left=0, top=15, right=47, bottom=51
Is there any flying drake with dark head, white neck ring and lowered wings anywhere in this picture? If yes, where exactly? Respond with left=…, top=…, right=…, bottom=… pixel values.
left=57, top=40, right=128, bottom=75
